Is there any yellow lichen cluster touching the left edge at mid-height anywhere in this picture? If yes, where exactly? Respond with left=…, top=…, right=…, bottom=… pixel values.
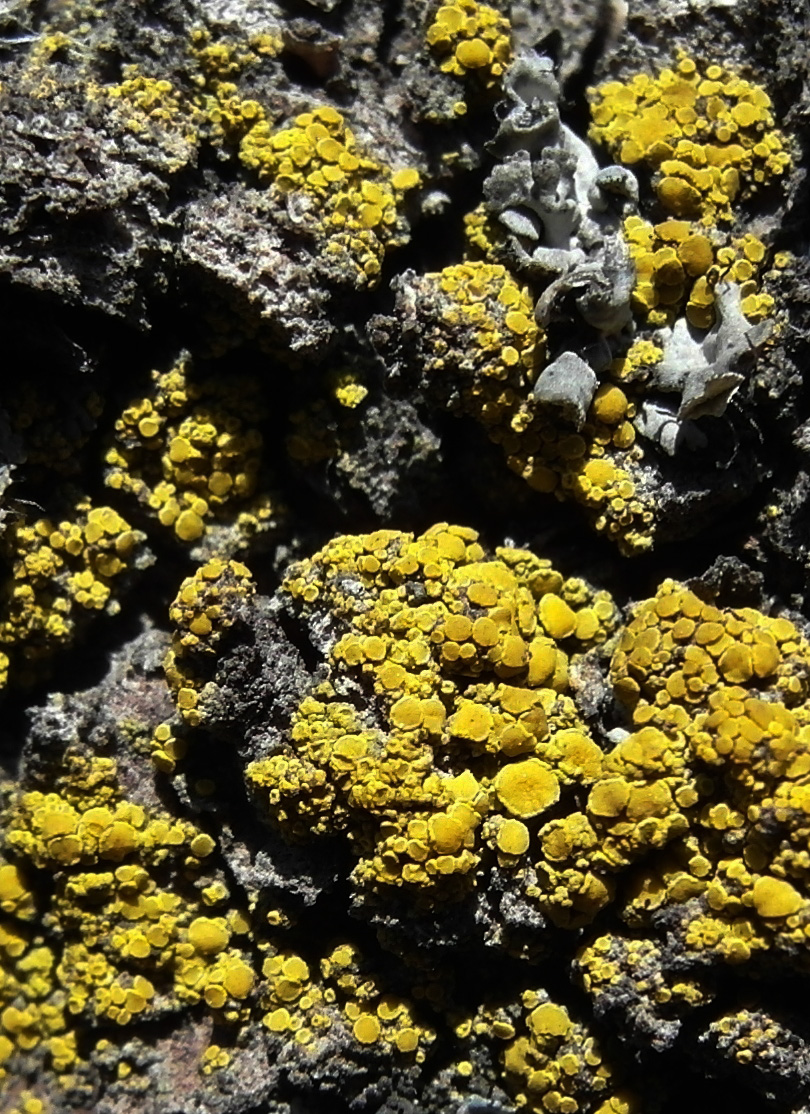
left=0, top=499, right=144, bottom=688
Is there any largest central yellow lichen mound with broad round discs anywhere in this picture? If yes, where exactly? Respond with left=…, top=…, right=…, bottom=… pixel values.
left=246, top=522, right=615, bottom=901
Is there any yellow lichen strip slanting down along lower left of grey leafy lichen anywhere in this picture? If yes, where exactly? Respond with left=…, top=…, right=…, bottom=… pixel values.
left=419, top=262, right=654, bottom=553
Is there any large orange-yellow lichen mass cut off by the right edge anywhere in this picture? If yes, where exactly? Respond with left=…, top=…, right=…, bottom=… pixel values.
left=606, top=580, right=810, bottom=964
